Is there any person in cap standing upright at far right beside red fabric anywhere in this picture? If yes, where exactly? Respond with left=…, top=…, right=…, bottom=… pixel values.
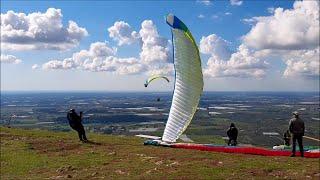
left=289, top=111, right=305, bottom=157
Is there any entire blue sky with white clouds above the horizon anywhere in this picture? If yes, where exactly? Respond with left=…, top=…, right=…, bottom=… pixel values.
left=1, top=0, right=319, bottom=91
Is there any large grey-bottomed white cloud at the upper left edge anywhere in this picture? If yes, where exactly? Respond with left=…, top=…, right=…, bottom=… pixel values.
left=1, top=8, right=88, bottom=50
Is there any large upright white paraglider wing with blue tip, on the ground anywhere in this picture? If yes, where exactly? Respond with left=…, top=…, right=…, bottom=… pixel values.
left=162, top=14, right=203, bottom=142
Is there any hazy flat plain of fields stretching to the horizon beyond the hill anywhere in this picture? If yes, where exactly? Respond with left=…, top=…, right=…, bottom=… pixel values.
left=0, top=92, right=320, bottom=148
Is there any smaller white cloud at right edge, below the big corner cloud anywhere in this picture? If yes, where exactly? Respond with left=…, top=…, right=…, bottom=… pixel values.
left=283, top=47, right=320, bottom=79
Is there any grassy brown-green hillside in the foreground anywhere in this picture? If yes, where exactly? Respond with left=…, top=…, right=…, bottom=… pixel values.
left=0, top=127, right=320, bottom=179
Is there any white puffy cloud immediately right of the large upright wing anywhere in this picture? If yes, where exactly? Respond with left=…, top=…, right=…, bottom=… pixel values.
left=199, top=34, right=268, bottom=78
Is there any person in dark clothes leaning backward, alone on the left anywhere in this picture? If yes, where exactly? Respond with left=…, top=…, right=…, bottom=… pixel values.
left=67, top=109, right=88, bottom=142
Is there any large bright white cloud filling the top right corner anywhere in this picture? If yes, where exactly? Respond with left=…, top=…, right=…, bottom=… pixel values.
left=243, top=1, right=319, bottom=50
